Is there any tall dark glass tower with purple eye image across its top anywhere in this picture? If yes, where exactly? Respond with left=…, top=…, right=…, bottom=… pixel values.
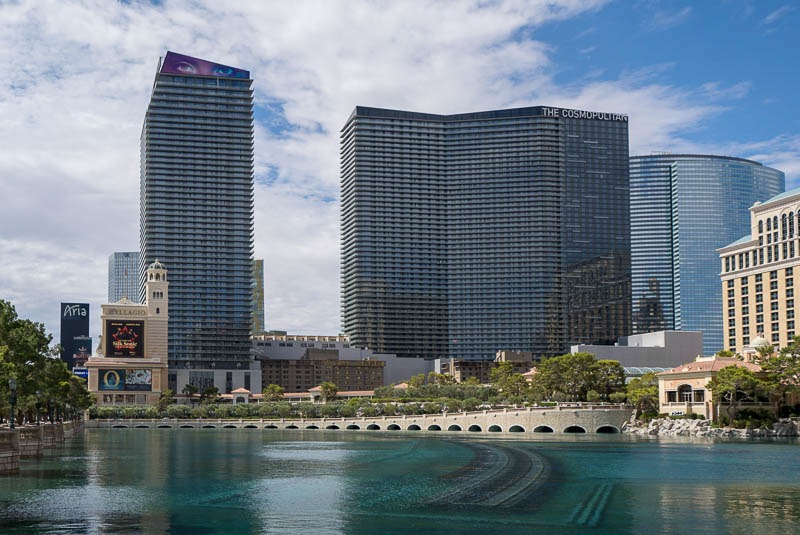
left=139, top=52, right=253, bottom=393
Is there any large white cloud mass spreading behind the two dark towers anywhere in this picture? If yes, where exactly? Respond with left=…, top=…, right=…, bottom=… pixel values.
left=0, top=0, right=800, bottom=344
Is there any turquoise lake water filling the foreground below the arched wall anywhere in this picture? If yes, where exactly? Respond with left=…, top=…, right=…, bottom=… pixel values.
left=0, top=429, right=800, bottom=535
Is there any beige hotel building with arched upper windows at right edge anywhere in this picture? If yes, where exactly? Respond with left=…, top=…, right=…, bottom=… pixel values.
left=717, top=188, right=800, bottom=353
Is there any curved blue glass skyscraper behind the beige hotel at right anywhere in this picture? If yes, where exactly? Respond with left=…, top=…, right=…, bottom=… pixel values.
left=630, top=154, right=785, bottom=354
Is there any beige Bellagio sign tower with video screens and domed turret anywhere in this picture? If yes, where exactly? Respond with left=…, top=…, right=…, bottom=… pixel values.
left=86, top=260, right=169, bottom=405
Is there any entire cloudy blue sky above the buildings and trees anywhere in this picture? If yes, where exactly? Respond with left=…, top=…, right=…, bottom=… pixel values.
left=0, top=0, right=800, bottom=342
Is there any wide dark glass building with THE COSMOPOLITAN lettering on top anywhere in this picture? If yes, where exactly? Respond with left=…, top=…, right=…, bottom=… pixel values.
left=341, top=107, right=630, bottom=360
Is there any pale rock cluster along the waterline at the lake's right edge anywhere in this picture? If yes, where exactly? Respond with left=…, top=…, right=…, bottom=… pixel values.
left=624, top=418, right=800, bottom=438
